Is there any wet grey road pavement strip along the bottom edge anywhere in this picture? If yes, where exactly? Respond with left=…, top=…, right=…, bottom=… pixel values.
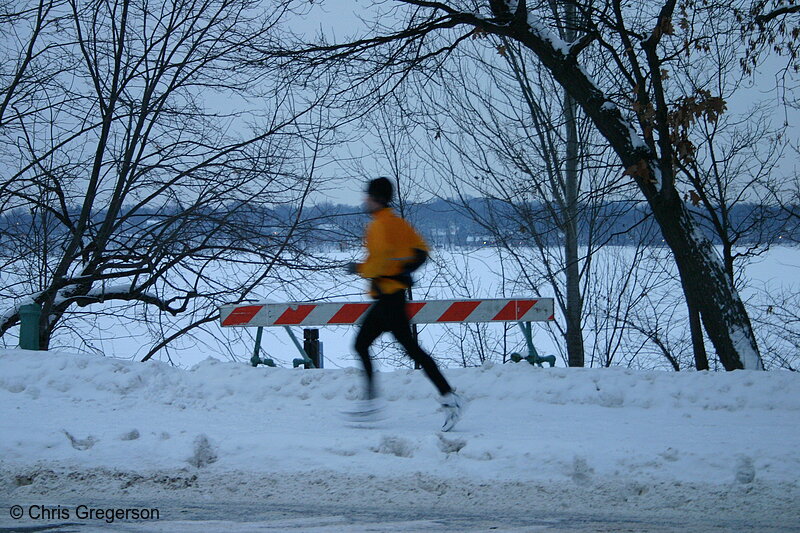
left=0, top=500, right=800, bottom=533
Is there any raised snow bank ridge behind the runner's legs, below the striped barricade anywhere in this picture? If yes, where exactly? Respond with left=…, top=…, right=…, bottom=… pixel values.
left=0, top=350, right=800, bottom=412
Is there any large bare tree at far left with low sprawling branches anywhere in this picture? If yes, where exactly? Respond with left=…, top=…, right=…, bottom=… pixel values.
left=0, top=0, right=340, bottom=358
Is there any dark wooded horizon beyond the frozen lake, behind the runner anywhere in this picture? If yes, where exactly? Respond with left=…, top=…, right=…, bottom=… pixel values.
left=0, top=198, right=799, bottom=246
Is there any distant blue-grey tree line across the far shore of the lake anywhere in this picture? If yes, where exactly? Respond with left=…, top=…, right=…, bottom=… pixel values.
left=0, top=198, right=788, bottom=249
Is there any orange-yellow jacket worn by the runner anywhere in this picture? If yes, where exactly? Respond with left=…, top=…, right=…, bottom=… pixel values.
left=356, top=207, right=429, bottom=297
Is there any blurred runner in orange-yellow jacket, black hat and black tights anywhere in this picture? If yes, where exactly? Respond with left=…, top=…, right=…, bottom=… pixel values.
left=348, top=178, right=461, bottom=431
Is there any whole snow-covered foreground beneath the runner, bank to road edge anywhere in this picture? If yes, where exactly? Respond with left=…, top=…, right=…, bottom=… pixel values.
left=0, top=350, right=800, bottom=531
